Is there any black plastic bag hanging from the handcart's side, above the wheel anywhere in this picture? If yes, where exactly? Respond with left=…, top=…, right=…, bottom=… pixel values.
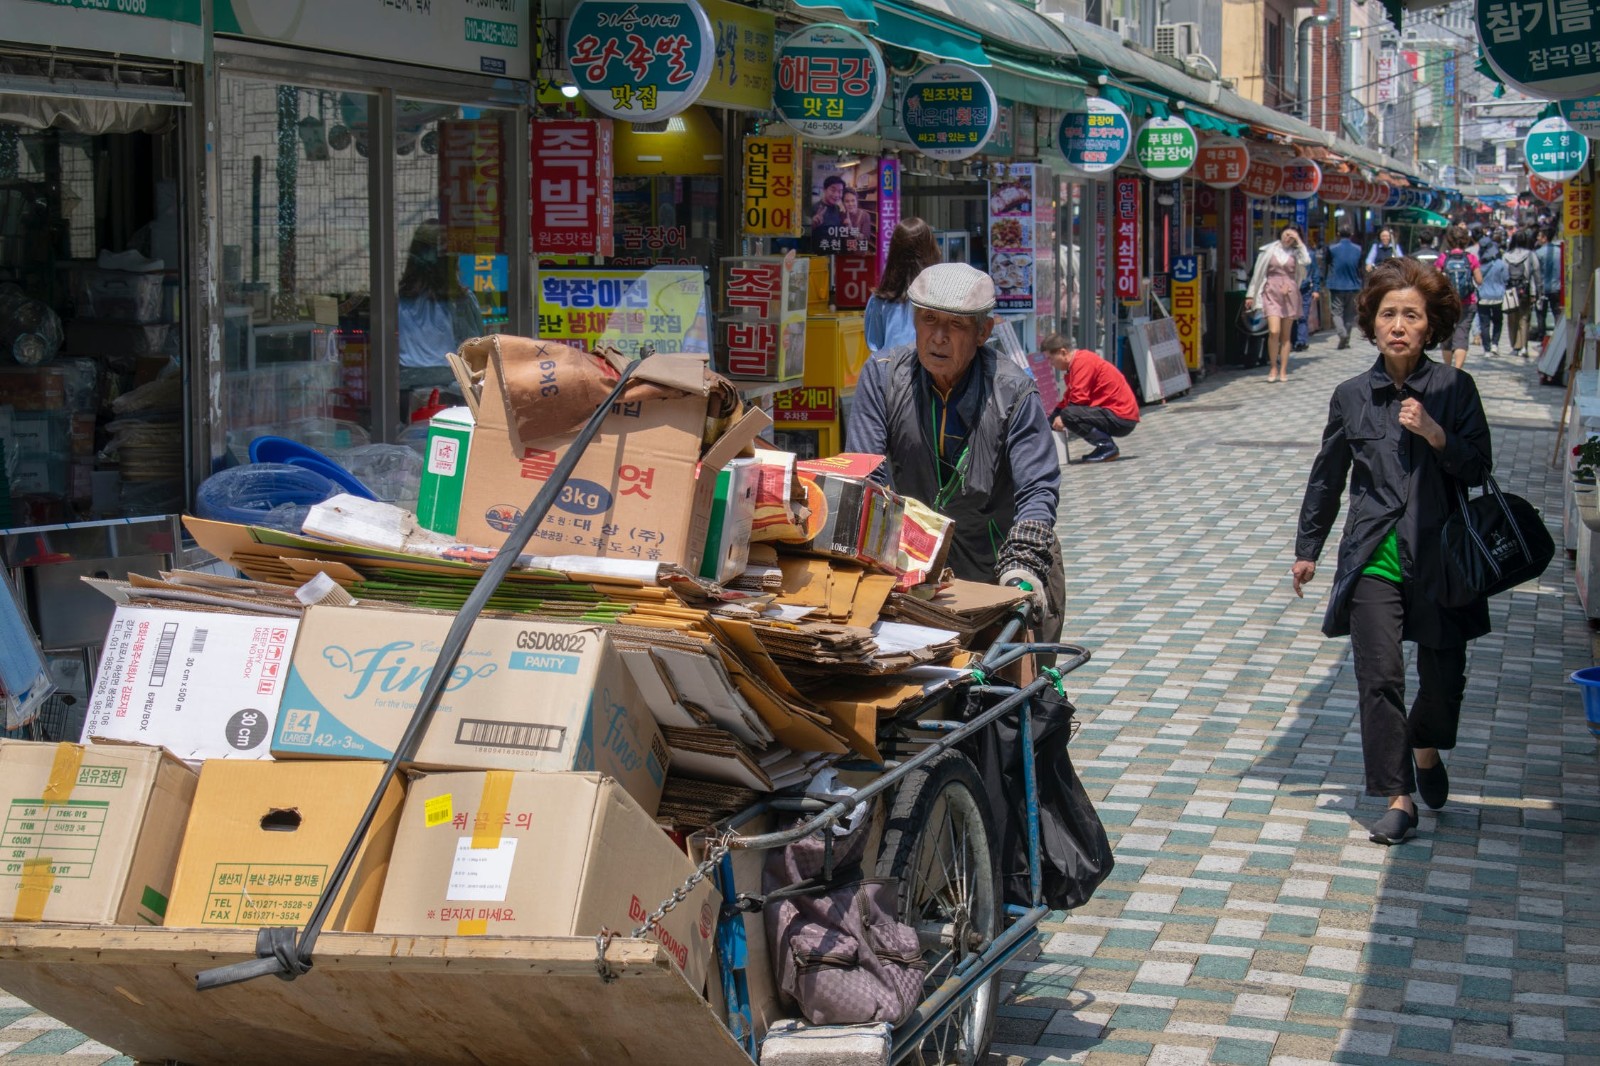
left=962, top=691, right=1114, bottom=911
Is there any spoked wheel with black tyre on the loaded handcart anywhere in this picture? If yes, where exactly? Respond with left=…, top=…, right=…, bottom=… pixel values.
left=878, top=751, right=1000, bottom=1066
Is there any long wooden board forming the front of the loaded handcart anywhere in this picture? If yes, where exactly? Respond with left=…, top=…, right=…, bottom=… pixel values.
left=0, top=922, right=750, bottom=1066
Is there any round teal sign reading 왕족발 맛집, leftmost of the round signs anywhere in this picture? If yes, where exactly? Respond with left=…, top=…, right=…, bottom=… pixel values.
left=563, top=0, right=717, bottom=122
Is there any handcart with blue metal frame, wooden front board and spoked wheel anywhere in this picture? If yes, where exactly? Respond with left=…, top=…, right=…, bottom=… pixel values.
left=0, top=352, right=1090, bottom=1066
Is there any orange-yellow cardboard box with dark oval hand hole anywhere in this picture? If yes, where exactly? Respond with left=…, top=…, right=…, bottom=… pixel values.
left=165, top=760, right=403, bottom=933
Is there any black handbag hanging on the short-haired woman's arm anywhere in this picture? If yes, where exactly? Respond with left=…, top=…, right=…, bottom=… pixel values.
left=1438, top=475, right=1555, bottom=607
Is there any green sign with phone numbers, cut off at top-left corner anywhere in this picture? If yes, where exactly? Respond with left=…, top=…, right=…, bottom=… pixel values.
left=0, top=0, right=205, bottom=62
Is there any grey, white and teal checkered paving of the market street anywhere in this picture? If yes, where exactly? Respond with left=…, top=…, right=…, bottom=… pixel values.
left=0, top=328, right=1600, bottom=1066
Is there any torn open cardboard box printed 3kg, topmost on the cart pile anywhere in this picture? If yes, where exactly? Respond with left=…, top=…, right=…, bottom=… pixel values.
left=454, top=338, right=771, bottom=571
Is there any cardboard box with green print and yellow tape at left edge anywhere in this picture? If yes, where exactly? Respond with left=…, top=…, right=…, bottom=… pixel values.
left=0, top=739, right=195, bottom=925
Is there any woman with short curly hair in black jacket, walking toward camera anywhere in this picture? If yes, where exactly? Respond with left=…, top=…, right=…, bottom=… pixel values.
left=1293, top=258, right=1493, bottom=844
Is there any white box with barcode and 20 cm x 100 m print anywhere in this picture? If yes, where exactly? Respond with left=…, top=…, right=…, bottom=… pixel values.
left=83, top=607, right=301, bottom=762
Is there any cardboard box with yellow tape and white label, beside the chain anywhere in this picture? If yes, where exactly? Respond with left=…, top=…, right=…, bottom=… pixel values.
left=374, top=771, right=722, bottom=988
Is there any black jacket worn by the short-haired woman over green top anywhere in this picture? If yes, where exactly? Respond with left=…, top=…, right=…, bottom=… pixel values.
left=1294, top=355, right=1493, bottom=648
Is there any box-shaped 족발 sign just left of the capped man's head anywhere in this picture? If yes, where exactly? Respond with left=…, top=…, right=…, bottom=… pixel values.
left=717, top=253, right=811, bottom=381
